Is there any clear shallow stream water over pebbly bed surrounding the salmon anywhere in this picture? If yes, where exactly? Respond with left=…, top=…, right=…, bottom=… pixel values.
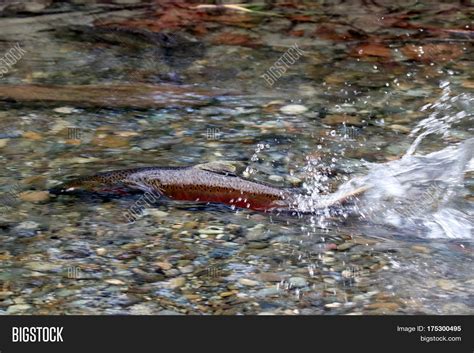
left=0, top=2, right=474, bottom=315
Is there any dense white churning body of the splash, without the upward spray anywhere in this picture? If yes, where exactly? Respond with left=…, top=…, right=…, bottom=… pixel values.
left=341, top=138, right=474, bottom=238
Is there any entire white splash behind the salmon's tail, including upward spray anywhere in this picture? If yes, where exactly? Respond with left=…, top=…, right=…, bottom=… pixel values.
left=298, top=82, right=474, bottom=239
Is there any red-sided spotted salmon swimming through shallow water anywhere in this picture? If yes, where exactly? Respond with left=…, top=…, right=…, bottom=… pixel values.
left=49, top=162, right=366, bottom=211
